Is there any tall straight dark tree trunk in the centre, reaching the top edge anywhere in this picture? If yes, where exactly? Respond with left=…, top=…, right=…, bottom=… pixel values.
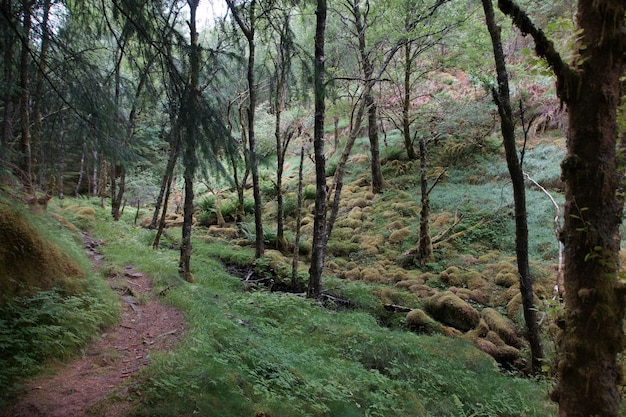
left=307, top=0, right=327, bottom=298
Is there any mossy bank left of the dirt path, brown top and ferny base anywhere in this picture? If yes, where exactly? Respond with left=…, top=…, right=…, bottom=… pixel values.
left=0, top=196, right=118, bottom=408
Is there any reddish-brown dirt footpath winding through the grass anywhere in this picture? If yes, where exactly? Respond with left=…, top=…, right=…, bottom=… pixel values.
left=0, top=236, right=185, bottom=417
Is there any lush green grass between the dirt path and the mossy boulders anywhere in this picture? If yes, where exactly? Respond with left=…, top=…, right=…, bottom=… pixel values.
left=84, top=204, right=554, bottom=417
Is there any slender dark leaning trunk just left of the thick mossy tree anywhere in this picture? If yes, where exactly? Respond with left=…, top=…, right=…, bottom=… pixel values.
left=482, top=0, right=544, bottom=373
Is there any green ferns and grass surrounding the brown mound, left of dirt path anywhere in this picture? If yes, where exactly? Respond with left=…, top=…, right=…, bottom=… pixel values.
left=0, top=197, right=118, bottom=408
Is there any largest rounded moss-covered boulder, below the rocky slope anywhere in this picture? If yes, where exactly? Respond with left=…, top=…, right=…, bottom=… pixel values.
left=425, top=291, right=480, bottom=331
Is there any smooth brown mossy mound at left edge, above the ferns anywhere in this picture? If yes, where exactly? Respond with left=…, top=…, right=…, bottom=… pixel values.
left=0, top=200, right=84, bottom=302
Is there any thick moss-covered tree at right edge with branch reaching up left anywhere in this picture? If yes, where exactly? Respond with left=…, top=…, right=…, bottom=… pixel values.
left=498, top=0, right=626, bottom=417
